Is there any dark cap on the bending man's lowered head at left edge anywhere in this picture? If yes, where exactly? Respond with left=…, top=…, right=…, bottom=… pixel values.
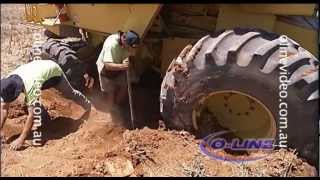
left=0, top=75, right=24, bottom=102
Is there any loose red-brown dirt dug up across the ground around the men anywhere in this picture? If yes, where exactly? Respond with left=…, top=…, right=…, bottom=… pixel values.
left=1, top=90, right=315, bottom=176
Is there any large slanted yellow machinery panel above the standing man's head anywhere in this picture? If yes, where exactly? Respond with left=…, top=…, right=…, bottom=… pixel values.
left=67, top=4, right=160, bottom=36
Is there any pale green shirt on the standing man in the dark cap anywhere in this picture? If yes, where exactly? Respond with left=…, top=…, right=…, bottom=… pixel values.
left=96, top=33, right=129, bottom=73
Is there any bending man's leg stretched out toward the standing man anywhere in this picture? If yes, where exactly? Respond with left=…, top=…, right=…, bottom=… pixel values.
left=55, top=74, right=91, bottom=111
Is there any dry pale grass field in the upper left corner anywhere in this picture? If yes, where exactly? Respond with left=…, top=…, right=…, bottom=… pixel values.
left=1, top=4, right=44, bottom=78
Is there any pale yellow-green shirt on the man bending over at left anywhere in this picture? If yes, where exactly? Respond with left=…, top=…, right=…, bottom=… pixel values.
left=9, top=60, right=63, bottom=106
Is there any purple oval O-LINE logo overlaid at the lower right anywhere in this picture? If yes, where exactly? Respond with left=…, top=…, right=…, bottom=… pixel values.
left=199, top=131, right=274, bottom=163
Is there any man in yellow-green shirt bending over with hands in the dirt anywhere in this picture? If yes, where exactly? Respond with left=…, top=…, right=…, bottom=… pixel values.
left=0, top=60, right=91, bottom=150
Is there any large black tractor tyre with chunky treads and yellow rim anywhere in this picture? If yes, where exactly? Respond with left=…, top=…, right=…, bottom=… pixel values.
left=160, top=28, right=319, bottom=164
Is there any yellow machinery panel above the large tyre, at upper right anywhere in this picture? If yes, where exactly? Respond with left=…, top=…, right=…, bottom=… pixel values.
left=216, top=4, right=318, bottom=56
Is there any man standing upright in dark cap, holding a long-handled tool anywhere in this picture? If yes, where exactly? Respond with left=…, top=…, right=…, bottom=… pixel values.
left=96, top=31, right=140, bottom=105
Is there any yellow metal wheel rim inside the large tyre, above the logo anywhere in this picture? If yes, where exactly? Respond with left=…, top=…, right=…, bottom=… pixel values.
left=192, top=90, right=276, bottom=139
